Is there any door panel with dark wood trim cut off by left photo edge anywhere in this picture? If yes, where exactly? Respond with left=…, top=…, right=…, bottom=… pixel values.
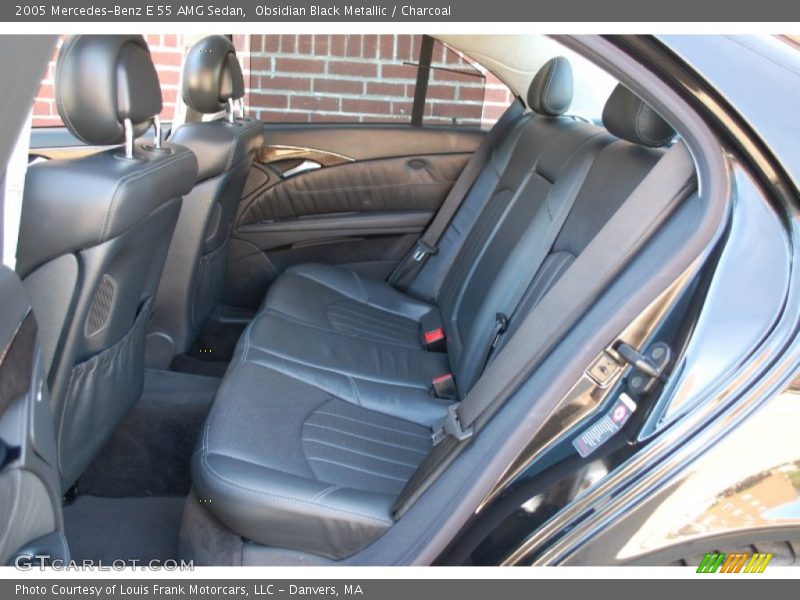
left=0, top=267, right=68, bottom=564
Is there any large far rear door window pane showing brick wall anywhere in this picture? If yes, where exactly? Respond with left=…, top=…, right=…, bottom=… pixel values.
left=239, top=34, right=422, bottom=123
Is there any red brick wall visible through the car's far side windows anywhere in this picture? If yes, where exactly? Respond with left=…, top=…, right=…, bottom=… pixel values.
left=33, top=34, right=513, bottom=127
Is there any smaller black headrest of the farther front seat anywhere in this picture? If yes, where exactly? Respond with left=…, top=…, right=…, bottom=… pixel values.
left=181, top=35, right=244, bottom=114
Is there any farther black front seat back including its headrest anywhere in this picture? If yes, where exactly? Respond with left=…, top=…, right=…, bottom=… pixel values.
left=147, top=35, right=264, bottom=367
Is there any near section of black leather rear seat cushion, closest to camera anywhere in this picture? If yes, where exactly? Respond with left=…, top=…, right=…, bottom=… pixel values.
left=193, top=360, right=431, bottom=558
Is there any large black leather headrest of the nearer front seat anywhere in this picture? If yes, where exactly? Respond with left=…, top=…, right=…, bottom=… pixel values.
left=55, top=35, right=162, bottom=146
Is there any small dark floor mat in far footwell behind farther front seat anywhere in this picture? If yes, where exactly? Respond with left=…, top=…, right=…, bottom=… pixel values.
left=169, top=323, right=246, bottom=377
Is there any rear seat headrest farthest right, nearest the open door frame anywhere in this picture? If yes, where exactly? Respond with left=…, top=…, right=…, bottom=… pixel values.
left=603, top=83, right=675, bottom=148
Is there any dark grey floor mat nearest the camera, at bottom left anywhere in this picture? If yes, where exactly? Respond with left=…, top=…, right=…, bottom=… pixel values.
left=64, top=496, right=185, bottom=564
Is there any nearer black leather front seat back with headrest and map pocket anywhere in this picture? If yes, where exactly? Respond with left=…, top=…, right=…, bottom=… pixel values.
left=17, top=35, right=197, bottom=488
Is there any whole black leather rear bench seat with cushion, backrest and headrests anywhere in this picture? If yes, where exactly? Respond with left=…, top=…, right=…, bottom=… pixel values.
left=193, top=59, right=672, bottom=558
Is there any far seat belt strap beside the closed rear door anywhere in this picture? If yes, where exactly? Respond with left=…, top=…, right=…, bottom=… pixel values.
left=389, top=98, right=525, bottom=290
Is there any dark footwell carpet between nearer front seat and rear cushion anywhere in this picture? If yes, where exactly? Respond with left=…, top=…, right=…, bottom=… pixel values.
left=78, top=369, right=219, bottom=498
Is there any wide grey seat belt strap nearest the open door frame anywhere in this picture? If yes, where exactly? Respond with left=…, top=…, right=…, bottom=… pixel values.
left=393, top=142, right=696, bottom=517
